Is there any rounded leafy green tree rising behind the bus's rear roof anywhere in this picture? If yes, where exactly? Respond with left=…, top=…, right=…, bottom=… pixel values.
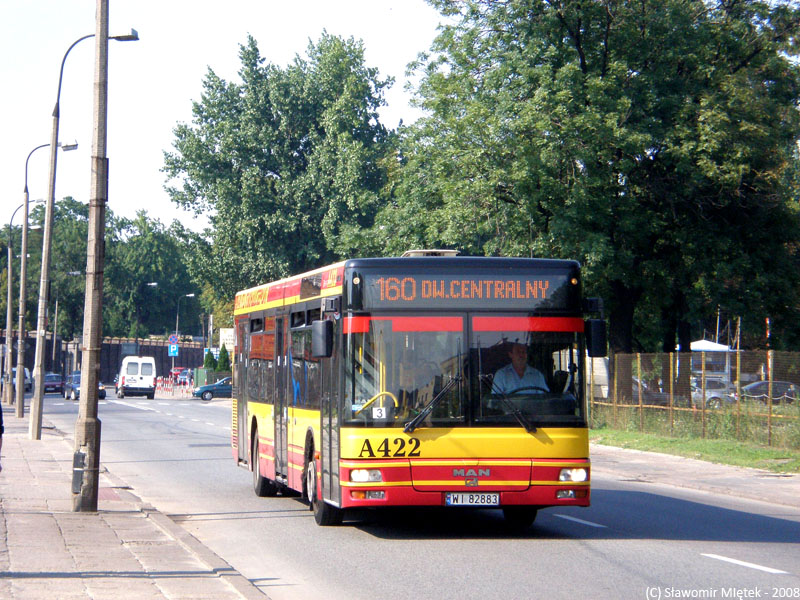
left=164, top=33, right=390, bottom=300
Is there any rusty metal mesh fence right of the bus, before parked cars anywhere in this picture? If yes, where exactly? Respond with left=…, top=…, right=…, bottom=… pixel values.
left=586, top=350, right=800, bottom=449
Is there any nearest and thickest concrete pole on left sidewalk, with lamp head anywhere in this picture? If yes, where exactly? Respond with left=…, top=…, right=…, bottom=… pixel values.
left=72, top=0, right=139, bottom=512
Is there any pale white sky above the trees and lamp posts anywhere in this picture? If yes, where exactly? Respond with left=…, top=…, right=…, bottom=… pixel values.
left=0, top=0, right=440, bottom=230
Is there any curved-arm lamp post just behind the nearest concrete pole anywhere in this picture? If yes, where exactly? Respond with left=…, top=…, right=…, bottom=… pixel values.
left=28, top=23, right=139, bottom=440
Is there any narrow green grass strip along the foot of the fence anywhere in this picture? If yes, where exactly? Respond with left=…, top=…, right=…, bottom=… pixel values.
left=589, top=427, right=800, bottom=473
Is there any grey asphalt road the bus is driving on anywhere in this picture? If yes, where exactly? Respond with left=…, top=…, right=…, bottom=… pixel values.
left=39, top=395, right=800, bottom=600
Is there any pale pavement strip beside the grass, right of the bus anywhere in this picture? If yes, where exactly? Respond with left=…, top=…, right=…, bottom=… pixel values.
left=589, top=444, right=800, bottom=508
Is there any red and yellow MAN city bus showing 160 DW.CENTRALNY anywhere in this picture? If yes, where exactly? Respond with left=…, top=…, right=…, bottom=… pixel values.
left=231, top=252, right=605, bottom=526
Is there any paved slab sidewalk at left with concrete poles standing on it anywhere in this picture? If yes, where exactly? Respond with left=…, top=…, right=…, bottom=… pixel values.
left=0, top=406, right=267, bottom=600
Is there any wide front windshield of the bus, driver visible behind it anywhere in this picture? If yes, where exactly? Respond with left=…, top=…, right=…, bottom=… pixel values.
left=343, top=313, right=584, bottom=430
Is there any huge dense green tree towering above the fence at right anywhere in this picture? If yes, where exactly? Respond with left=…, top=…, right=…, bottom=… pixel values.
left=388, top=0, right=800, bottom=351
